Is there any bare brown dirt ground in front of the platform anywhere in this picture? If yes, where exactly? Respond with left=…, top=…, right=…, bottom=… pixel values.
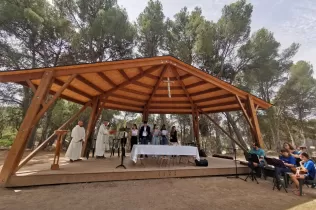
left=0, top=177, right=316, bottom=210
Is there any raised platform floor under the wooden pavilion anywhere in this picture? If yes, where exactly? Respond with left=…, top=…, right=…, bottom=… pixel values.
left=6, top=154, right=248, bottom=187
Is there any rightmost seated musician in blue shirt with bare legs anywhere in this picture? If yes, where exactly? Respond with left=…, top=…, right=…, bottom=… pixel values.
left=291, top=152, right=316, bottom=194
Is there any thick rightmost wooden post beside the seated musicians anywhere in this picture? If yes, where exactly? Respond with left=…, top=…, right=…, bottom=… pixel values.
left=247, top=96, right=264, bottom=148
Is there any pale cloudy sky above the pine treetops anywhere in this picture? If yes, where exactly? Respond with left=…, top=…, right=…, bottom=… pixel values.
left=118, top=0, right=316, bottom=78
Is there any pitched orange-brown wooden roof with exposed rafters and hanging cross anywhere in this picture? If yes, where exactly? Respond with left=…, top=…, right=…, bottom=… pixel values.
left=0, top=56, right=271, bottom=114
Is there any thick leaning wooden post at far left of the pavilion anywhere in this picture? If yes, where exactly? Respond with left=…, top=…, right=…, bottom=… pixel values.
left=0, top=71, right=53, bottom=184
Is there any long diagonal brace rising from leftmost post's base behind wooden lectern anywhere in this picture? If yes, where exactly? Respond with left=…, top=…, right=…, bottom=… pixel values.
left=16, top=102, right=90, bottom=171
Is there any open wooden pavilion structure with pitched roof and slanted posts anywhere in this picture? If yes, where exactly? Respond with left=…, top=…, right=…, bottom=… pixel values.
left=0, top=56, right=271, bottom=187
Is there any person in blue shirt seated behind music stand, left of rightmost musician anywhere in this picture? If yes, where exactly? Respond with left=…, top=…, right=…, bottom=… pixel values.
left=274, top=149, right=296, bottom=190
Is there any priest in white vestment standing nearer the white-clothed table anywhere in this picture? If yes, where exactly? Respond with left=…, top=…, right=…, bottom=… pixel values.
left=95, top=121, right=110, bottom=159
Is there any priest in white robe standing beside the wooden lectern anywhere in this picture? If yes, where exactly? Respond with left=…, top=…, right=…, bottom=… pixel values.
left=65, top=121, right=86, bottom=162
